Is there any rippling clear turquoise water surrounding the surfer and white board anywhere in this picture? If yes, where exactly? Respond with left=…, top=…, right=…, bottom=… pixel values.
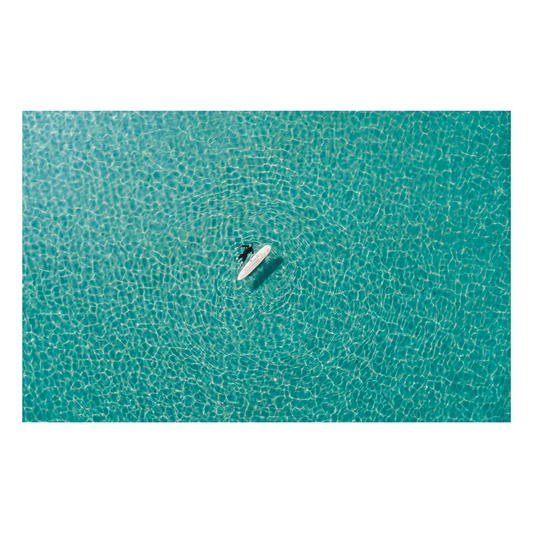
left=23, top=112, right=511, bottom=422
